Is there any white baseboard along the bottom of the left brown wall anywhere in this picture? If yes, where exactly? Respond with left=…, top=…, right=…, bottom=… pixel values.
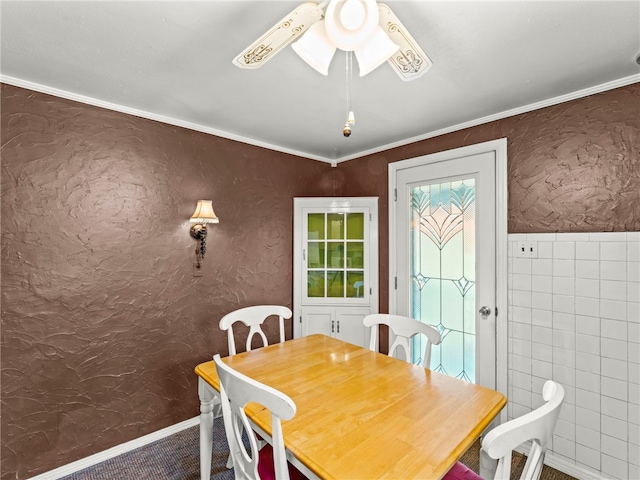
left=29, top=416, right=200, bottom=480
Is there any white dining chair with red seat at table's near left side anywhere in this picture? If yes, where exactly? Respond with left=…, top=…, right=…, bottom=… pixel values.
left=213, top=354, right=305, bottom=480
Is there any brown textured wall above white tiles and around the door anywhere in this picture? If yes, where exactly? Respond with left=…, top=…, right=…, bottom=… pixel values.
left=336, top=84, right=640, bottom=342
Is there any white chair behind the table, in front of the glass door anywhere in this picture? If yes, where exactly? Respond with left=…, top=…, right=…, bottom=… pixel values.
left=363, top=313, right=442, bottom=368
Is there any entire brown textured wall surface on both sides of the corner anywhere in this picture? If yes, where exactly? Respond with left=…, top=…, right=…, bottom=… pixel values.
left=1, top=80, right=640, bottom=480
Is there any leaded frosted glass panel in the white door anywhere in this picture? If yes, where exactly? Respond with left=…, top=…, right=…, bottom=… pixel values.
left=410, top=178, right=476, bottom=382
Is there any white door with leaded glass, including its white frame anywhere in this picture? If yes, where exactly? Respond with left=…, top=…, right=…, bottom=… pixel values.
left=389, top=140, right=507, bottom=389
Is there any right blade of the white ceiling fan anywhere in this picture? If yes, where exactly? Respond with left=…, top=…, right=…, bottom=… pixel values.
left=378, top=3, right=433, bottom=82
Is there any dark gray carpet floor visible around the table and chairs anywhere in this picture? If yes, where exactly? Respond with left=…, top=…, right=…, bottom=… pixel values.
left=61, top=418, right=575, bottom=480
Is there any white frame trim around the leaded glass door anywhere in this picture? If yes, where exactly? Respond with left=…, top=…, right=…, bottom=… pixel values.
left=389, top=138, right=509, bottom=402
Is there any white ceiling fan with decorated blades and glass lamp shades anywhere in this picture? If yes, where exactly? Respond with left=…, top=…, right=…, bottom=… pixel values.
left=233, top=0, right=432, bottom=81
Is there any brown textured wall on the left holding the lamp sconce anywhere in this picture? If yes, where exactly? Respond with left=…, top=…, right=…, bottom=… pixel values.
left=1, top=85, right=335, bottom=480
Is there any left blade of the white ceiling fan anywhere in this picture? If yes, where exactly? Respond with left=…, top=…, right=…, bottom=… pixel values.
left=233, top=2, right=323, bottom=68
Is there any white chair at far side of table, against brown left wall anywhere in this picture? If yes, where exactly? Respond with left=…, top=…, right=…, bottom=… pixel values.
left=220, top=305, right=293, bottom=355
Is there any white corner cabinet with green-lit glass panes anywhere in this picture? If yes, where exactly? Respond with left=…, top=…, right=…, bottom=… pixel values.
left=294, top=197, right=378, bottom=346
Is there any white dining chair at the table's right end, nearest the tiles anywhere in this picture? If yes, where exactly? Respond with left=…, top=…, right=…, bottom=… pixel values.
left=443, top=380, right=564, bottom=480
